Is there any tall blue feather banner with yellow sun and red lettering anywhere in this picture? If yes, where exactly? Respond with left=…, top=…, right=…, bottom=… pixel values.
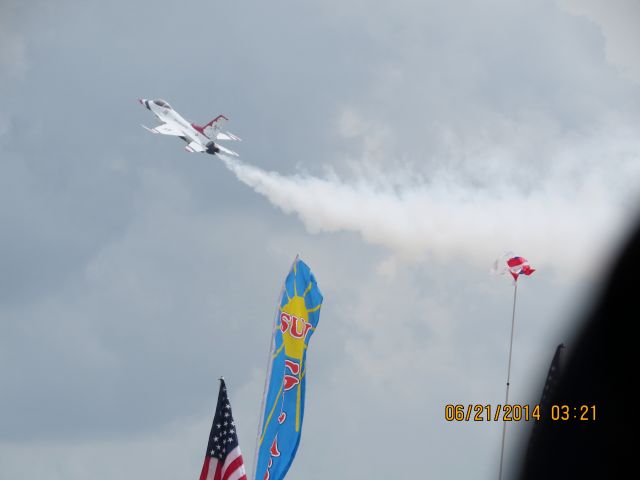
left=255, top=257, right=322, bottom=480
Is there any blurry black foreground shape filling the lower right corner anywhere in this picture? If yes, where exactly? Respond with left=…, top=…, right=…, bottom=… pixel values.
left=518, top=219, right=640, bottom=480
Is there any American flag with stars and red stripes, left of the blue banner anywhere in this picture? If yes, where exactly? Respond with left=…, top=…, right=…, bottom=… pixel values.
left=200, top=378, right=247, bottom=480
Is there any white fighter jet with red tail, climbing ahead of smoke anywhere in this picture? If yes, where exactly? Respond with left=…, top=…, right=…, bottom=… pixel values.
left=138, top=98, right=240, bottom=157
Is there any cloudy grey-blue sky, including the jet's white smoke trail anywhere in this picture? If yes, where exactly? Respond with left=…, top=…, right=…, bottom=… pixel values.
left=0, top=0, right=640, bottom=480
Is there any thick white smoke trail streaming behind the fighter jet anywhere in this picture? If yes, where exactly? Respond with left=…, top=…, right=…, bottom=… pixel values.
left=222, top=144, right=640, bottom=272
